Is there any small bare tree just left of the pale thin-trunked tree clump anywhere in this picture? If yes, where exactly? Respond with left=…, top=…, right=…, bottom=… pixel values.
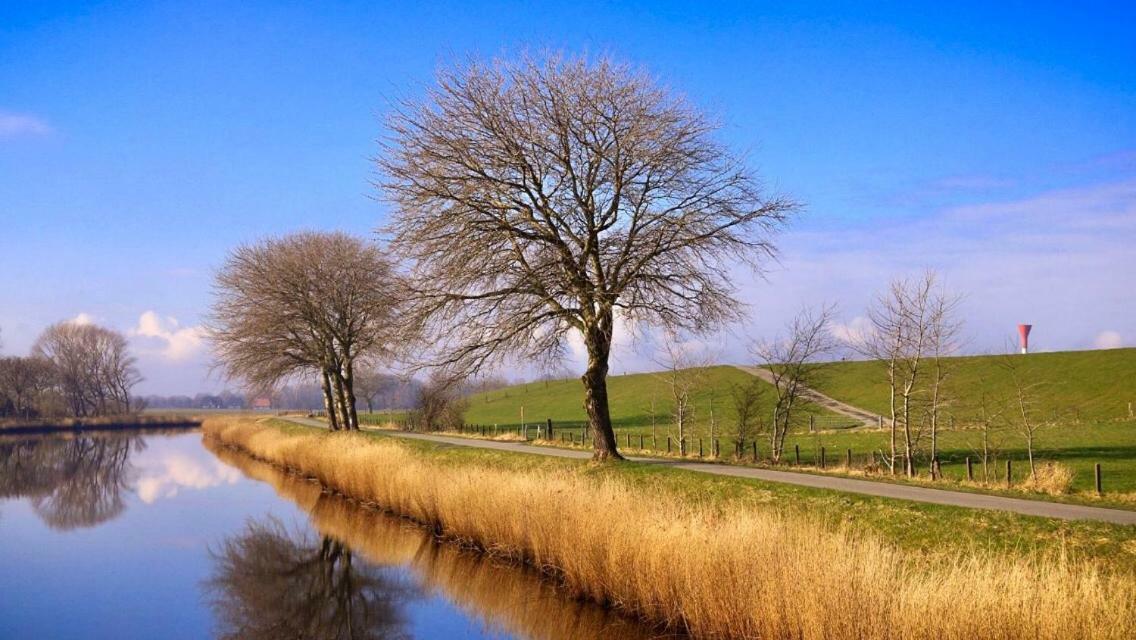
left=751, top=305, right=837, bottom=463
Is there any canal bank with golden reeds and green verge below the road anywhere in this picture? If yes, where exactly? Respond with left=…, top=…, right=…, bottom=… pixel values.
left=204, top=418, right=1136, bottom=639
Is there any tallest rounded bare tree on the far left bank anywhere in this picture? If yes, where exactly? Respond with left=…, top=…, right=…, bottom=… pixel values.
left=32, top=322, right=142, bottom=417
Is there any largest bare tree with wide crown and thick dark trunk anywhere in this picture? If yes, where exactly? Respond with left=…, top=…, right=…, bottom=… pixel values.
left=378, top=56, right=795, bottom=459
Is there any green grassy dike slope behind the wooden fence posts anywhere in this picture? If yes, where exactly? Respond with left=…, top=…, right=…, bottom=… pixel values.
left=454, top=349, right=1136, bottom=508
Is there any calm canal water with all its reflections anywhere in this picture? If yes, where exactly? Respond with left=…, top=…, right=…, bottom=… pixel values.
left=0, top=433, right=663, bottom=640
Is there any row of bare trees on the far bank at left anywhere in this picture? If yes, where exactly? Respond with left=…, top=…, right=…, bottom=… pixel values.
left=0, top=322, right=142, bottom=419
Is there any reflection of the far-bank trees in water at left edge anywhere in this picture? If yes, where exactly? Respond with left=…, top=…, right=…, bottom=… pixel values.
left=0, top=434, right=145, bottom=531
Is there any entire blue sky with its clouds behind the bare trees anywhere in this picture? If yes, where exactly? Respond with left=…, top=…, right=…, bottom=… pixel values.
left=0, top=1, right=1136, bottom=392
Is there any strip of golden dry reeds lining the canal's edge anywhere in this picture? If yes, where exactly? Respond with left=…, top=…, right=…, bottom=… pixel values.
left=204, top=421, right=1136, bottom=639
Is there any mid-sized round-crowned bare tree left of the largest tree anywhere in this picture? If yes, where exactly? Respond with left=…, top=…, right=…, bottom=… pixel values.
left=208, top=232, right=404, bottom=430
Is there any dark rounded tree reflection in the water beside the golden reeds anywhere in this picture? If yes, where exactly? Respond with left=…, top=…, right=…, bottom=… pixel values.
left=208, top=520, right=417, bottom=640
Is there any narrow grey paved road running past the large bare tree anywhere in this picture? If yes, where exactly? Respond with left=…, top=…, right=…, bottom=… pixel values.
left=277, top=416, right=1136, bottom=525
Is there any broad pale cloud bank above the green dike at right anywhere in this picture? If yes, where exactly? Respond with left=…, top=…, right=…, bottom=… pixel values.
left=738, top=177, right=1136, bottom=352
